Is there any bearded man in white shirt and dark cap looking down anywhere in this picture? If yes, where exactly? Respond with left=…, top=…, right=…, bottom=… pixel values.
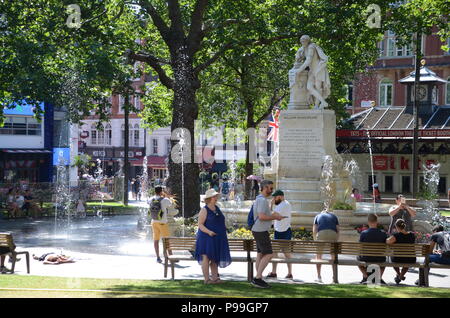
left=267, top=190, right=293, bottom=279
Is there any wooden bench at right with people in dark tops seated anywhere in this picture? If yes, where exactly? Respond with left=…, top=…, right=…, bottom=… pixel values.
left=337, top=242, right=430, bottom=286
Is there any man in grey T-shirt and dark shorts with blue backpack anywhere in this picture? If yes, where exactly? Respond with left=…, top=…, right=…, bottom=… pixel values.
left=248, top=180, right=283, bottom=288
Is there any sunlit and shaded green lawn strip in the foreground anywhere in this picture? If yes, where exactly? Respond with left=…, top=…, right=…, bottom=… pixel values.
left=0, top=275, right=450, bottom=298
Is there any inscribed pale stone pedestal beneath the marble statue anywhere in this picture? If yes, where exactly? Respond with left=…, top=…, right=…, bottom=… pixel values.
left=277, top=109, right=336, bottom=215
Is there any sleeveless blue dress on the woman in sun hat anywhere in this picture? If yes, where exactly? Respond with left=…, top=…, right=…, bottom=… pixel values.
left=195, top=206, right=231, bottom=268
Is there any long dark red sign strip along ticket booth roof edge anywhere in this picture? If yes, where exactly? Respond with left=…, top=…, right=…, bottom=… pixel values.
left=336, top=129, right=450, bottom=138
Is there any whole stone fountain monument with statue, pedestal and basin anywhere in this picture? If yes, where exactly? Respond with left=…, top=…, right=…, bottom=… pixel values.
left=222, top=36, right=390, bottom=240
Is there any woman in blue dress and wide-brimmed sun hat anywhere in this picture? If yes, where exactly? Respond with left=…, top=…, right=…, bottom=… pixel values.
left=195, top=189, right=231, bottom=284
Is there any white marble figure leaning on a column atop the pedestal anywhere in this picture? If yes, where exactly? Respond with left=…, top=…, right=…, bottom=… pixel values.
left=289, top=35, right=331, bottom=109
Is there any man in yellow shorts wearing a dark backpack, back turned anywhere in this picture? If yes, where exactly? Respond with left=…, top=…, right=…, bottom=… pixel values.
left=148, top=186, right=172, bottom=263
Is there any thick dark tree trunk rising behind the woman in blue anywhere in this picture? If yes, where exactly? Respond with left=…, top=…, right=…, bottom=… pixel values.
left=168, top=54, right=200, bottom=217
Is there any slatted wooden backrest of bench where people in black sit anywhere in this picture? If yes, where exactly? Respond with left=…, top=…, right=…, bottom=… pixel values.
left=339, top=242, right=429, bottom=257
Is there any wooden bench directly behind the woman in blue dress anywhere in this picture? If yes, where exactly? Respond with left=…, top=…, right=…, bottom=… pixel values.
left=162, top=237, right=253, bottom=281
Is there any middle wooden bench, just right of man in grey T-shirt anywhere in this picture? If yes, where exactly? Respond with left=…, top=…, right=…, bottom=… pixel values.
left=250, top=240, right=338, bottom=283
